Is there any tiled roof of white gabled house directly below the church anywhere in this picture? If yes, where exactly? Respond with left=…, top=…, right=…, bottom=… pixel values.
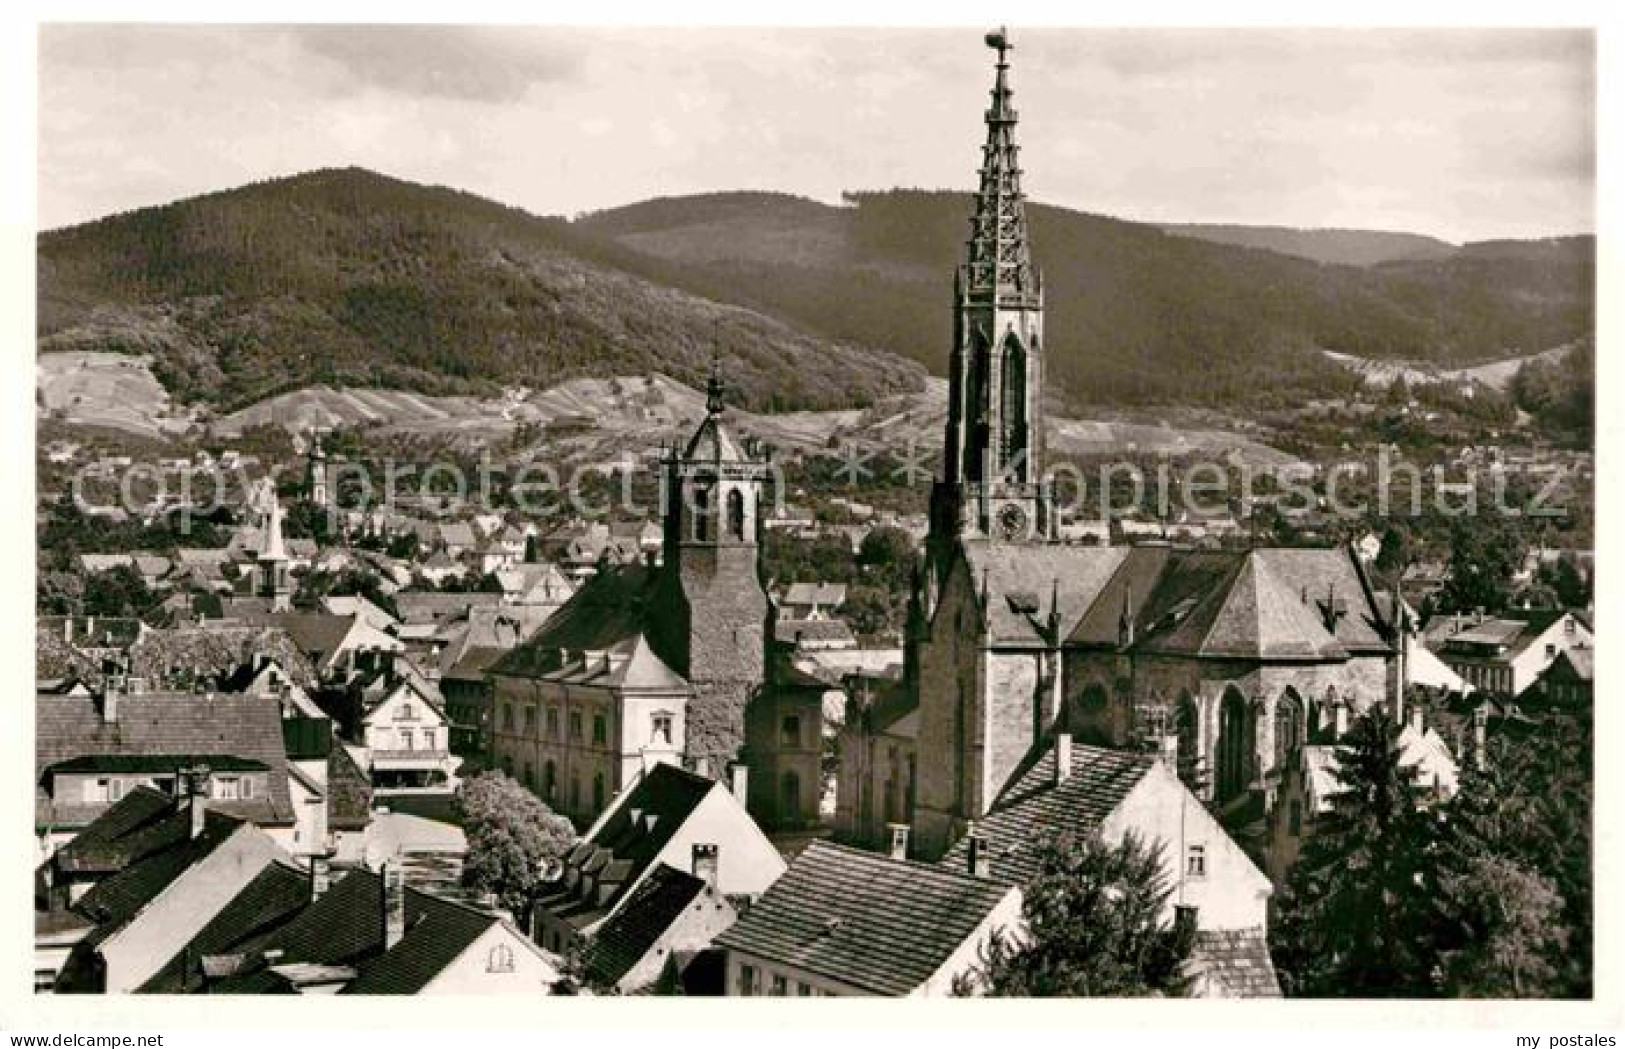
left=941, top=744, right=1154, bottom=883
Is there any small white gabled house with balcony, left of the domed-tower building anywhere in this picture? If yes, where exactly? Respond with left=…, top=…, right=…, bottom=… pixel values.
left=361, top=679, right=463, bottom=797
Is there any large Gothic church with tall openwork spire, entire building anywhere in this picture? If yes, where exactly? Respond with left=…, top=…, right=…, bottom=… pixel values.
left=871, top=34, right=1402, bottom=859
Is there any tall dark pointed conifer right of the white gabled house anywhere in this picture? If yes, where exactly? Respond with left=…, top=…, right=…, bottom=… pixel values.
left=1271, top=706, right=1437, bottom=997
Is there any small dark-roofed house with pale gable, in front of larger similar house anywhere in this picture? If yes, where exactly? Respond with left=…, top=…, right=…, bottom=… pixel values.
left=582, top=864, right=739, bottom=994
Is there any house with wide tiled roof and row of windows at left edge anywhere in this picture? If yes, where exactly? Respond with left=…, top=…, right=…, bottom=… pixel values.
left=34, top=684, right=297, bottom=857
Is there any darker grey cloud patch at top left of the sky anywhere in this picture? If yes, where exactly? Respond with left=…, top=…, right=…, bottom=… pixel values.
left=291, top=26, right=580, bottom=104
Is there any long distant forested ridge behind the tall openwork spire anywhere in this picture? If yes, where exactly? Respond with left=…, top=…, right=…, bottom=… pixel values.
left=574, top=190, right=1594, bottom=404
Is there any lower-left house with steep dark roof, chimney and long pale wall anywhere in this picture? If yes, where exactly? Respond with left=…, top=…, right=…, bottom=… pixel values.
left=55, top=796, right=286, bottom=994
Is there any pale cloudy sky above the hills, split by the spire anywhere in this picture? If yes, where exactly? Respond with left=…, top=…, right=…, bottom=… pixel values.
left=37, top=24, right=1596, bottom=242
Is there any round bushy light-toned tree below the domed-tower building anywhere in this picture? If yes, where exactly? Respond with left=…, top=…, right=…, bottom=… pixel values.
left=457, top=771, right=575, bottom=916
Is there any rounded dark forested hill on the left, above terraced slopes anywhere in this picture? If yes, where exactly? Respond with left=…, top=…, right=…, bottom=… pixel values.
left=37, top=169, right=923, bottom=411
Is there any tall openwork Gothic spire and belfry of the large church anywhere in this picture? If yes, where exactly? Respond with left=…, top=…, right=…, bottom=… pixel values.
left=931, top=29, right=1056, bottom=559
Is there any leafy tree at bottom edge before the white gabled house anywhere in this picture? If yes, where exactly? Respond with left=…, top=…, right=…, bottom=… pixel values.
left=954, top=835, right=1193, bottom=997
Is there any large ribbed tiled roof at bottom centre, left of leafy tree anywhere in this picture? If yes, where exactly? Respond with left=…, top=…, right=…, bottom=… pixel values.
left=717, top=841, right=1016, bottom=995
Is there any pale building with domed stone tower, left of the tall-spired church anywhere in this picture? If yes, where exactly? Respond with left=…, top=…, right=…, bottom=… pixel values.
left=474, top=370, right=822, bottom=828
